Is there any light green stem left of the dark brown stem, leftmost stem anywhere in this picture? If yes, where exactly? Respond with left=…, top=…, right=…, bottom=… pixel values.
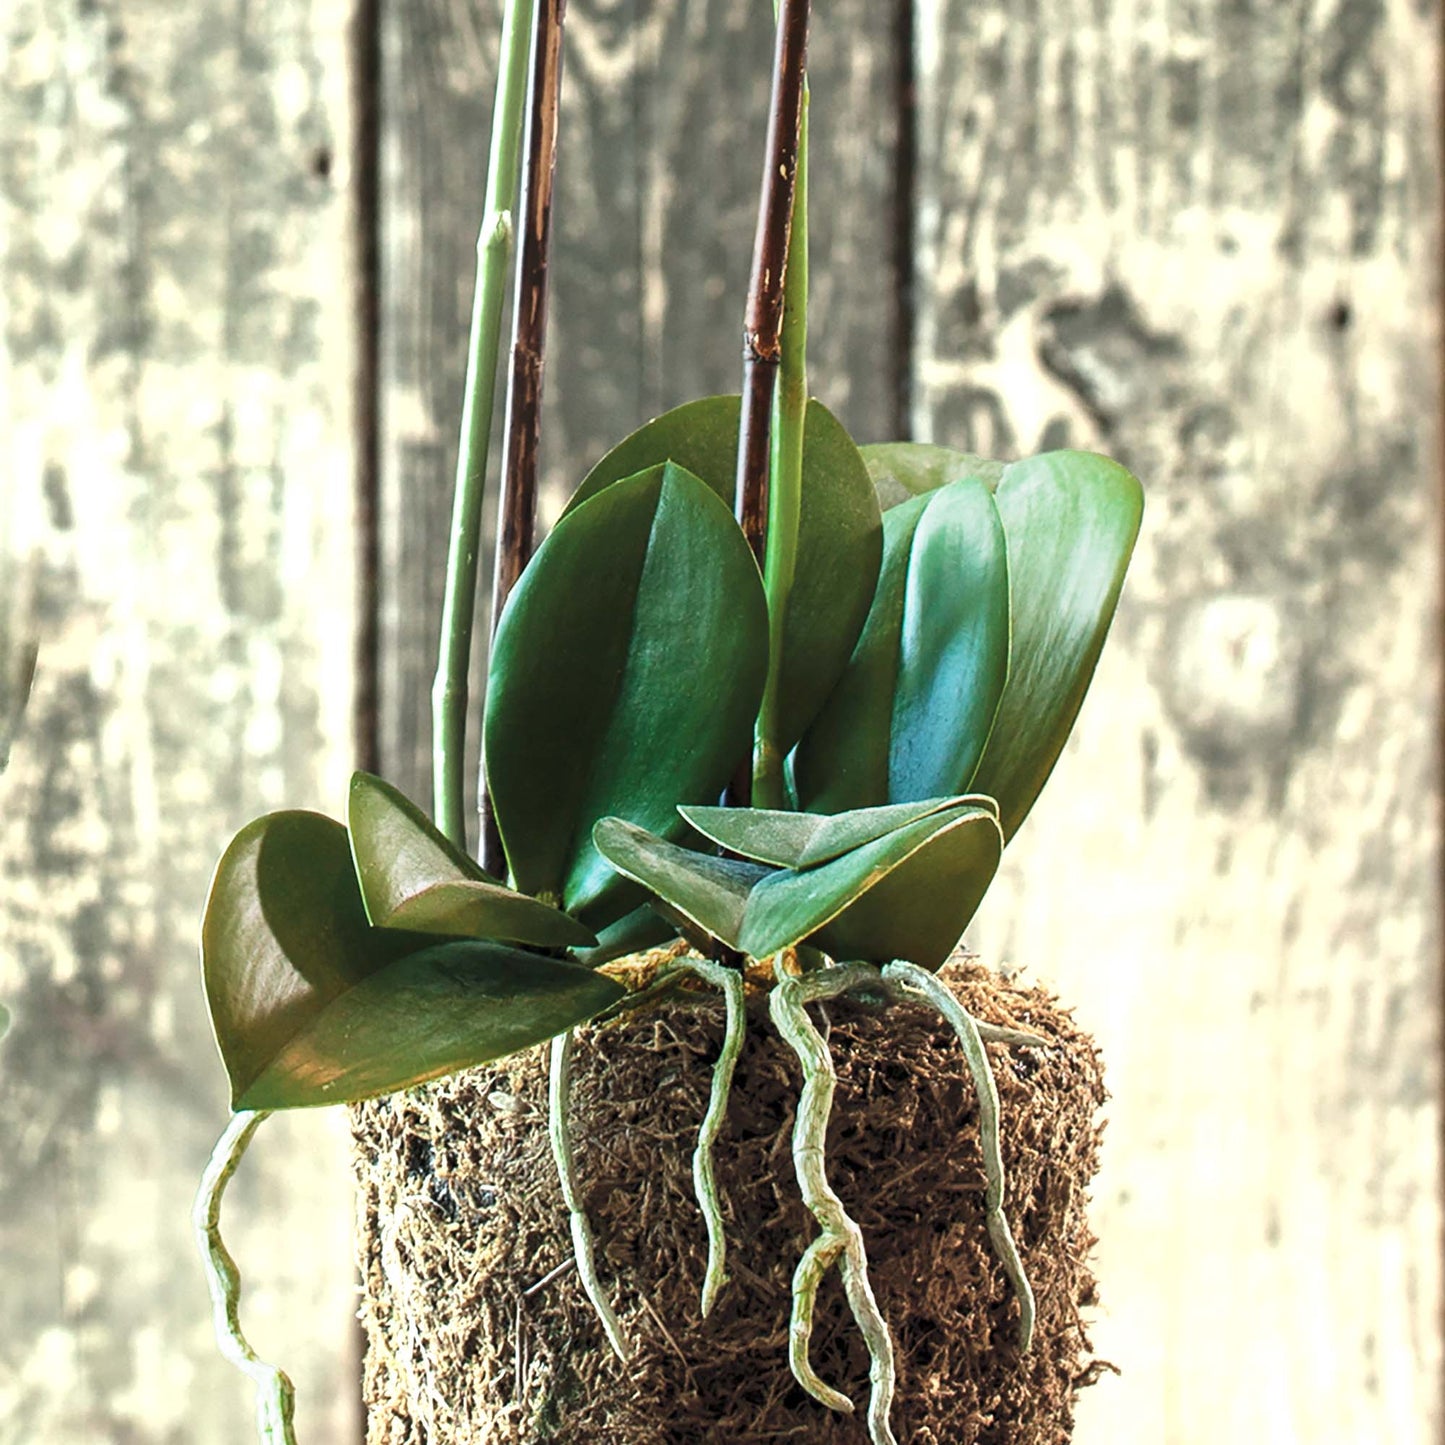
left=432, top=0, right=535, bottom=848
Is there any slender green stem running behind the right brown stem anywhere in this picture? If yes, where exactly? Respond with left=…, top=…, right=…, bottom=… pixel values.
left=753, top=81, right=809, bottom=808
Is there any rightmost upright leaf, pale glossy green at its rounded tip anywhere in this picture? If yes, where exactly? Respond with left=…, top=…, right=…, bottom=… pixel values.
left=972, top=452, right=1143, bottom=840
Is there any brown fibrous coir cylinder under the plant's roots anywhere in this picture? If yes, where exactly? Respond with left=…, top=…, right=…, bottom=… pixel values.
left=346, top=962, right=1104, bottom=1445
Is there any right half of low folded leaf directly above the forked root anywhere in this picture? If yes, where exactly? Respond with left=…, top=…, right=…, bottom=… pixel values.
left=738, top=806, right=1003, bottom=968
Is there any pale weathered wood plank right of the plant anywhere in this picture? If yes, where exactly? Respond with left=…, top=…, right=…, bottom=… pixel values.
left=916, top=0, right=1441, bottom=1445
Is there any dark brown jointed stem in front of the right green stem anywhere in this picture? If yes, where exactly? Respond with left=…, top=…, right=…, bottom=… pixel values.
left=728, top=0, right=808, bottom=806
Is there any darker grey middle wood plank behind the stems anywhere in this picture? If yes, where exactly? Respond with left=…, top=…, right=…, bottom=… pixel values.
left=381, top=0, right=899, bottom=826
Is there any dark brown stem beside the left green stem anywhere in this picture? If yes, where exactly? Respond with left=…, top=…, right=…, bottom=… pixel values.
left=480, top=0, right=566, bottom=877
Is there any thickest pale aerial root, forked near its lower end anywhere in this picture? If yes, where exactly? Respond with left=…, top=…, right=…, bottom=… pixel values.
left=769, top=964, right=897, bottom=1445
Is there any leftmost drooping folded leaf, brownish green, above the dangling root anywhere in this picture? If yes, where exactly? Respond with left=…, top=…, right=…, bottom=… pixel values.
left=201, top=812, right=623, bottom=1110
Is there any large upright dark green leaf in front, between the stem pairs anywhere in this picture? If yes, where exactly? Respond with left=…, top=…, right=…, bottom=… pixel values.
left=484, top=462, right=767, bottom=925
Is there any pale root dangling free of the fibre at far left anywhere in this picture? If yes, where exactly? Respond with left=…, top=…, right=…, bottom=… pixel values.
left=191, top=1110, right=296, bottom=1445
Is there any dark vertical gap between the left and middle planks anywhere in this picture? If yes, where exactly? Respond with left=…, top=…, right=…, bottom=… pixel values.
left=342, top=0, right=383, bottom=1445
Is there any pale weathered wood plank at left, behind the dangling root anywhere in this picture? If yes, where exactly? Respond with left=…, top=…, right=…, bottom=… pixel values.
left=0, top=0, right=355, bottom=1445
